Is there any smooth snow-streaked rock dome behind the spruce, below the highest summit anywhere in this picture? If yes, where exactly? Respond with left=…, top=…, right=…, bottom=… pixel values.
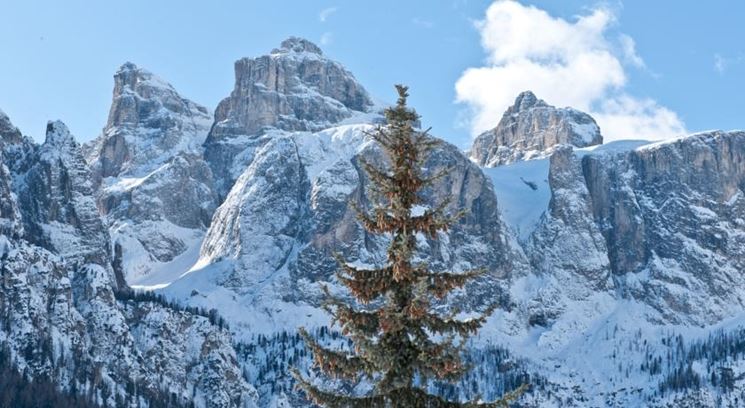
left=165, top=119, right=527, bottom=333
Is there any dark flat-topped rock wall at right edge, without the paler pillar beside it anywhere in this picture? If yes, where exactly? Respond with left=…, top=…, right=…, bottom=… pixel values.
left=582, top=132, right=745, bottom=324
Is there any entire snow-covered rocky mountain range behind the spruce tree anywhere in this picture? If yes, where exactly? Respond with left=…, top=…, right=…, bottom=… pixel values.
left=0, top=37, right=745, bottom=407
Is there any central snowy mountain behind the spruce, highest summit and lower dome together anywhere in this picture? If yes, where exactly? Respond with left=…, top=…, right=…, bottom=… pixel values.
left=164, top=38, right=527, bottom=337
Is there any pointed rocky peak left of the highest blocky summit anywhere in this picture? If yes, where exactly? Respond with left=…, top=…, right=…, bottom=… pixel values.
left=87, top=63, right=217, bottom=285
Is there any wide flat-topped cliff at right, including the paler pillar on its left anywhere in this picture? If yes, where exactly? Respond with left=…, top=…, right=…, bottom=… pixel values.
left=526, top=132, right=745, bottom=325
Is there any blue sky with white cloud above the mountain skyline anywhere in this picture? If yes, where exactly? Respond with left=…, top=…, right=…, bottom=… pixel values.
left=0, top=0, right=745, bottom=147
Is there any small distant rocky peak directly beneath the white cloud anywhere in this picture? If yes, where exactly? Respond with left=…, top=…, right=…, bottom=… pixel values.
left=471, top=91, right=603, bottom=167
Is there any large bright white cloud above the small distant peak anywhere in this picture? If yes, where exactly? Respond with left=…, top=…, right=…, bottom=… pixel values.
left=455, top=0, right=685, bottom=140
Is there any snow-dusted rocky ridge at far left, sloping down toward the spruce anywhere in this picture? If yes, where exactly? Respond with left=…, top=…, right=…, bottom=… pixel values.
left=0, top=110, right=255, bottom=407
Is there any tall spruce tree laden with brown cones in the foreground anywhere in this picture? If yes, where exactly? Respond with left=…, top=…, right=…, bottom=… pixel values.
left=293, top=85, right=520, bottom=408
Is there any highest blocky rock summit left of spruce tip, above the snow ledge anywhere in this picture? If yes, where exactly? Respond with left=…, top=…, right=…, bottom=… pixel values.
left=205, top=37, right=373, bottom=196
